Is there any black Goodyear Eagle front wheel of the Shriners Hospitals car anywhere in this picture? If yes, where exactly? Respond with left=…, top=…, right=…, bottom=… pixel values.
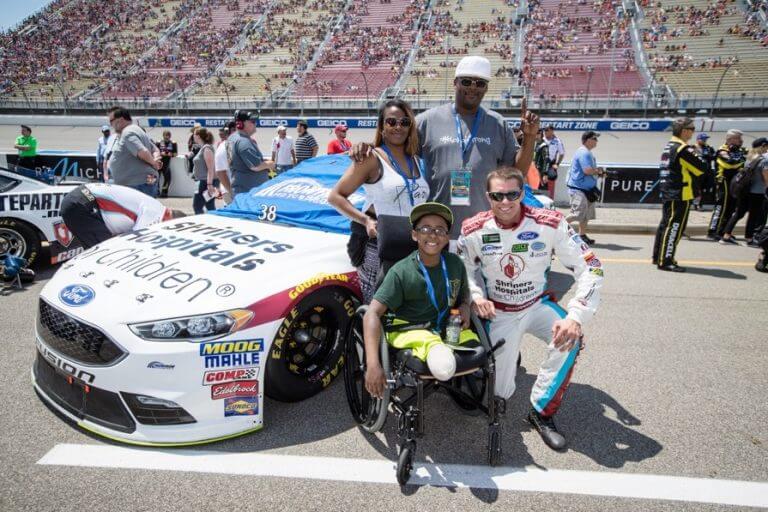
left=265, top=288, right=354, bottom=402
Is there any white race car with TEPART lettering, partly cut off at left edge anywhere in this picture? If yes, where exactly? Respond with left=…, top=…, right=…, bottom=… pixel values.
left=0, top=167, right=83, bottom=265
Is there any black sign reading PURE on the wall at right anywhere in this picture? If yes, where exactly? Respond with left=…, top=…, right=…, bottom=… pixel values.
left=602, top=165, right=661, bottom=204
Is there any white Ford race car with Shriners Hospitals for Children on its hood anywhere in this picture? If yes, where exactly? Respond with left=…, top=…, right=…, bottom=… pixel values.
left=32, top=155, right=556, bottom=446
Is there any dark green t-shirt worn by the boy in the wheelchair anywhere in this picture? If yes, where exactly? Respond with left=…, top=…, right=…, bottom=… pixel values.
left=373, top=251, right=469, bottom=332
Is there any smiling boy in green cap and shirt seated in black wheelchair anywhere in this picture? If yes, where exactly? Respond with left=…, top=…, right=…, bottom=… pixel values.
left=344, top=203, right=504, bottom=485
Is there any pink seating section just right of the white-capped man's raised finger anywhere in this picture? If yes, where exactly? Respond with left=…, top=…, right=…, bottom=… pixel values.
left=523, top=0, right=644, bottom=99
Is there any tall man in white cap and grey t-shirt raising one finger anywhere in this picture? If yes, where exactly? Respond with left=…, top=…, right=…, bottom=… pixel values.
left=352, top=56, right=539, bottom=239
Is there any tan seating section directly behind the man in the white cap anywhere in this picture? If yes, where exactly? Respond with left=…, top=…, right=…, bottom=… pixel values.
left=405, top=0, right=517, bottom=103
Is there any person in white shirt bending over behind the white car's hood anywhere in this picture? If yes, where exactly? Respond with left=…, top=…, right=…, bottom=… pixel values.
left=61, top=183, right=184, bottom=249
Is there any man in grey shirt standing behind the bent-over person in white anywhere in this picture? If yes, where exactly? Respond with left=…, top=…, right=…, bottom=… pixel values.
left=107, top=107, right=163, bottom=197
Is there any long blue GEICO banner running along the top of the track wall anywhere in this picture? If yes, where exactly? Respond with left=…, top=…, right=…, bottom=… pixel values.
left=148, top=117, right=672, bottom=132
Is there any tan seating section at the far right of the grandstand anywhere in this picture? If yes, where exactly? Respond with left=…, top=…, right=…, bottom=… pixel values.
left=640, top=0, right=768, bottom=98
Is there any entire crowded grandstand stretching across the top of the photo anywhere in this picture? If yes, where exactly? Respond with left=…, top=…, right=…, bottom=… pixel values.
left=0, top=0, right=768, bottom=109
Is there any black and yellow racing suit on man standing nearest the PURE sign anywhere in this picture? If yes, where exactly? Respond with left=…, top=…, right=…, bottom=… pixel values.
left=653, top=137, right=707, bottom=266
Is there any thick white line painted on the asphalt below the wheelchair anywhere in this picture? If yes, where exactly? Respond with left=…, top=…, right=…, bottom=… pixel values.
left=37, top=444, right=768, bottom=508
